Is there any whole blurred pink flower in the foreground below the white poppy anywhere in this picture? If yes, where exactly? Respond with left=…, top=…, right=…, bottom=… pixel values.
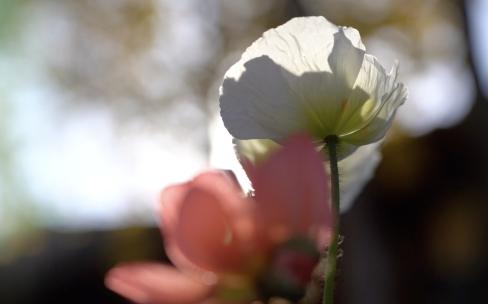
left=106, top=135, right=331, bottom=304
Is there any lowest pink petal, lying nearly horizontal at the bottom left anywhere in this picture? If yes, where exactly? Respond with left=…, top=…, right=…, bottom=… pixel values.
left=105, top=263, right=212, bottom=304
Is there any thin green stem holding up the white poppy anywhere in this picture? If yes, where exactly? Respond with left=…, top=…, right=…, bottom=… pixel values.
left=322, top=136, right=340, bottom=304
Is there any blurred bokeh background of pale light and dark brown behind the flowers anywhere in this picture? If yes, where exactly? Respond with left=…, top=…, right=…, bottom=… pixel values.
left=0, top=0, right=488, bottom=304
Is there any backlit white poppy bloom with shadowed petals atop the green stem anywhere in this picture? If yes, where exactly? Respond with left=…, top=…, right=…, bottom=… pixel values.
left=220, top=17, right=406, bottom=158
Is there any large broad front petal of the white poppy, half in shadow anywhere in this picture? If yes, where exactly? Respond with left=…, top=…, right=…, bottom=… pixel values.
left=220, top=17, right=364, bottom=142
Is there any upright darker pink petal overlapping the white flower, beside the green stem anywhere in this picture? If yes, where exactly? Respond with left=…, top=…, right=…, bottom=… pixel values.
left=251, top=135, right=331, bottom=245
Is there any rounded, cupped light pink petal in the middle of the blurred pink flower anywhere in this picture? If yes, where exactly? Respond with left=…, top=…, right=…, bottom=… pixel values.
left=162, top=171, right=253, bottom=272
